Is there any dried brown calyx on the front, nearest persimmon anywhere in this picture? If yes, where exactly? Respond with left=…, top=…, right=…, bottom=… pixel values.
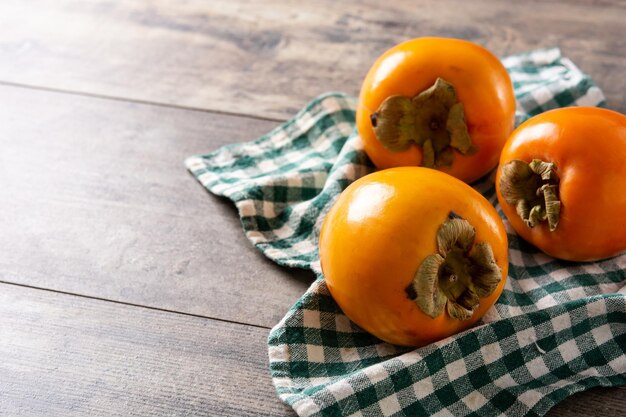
left=406, top=212, right=502, bottom=320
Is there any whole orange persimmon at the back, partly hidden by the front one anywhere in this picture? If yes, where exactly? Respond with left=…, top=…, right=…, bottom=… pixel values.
left=356, top=38, right=515, bottom=183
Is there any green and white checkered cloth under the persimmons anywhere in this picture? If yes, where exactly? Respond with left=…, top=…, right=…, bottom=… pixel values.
left=186, top=49, right=626, bottom=416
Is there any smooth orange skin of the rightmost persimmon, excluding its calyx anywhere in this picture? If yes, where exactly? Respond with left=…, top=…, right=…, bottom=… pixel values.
left=496, top=107, right=626, bottom=261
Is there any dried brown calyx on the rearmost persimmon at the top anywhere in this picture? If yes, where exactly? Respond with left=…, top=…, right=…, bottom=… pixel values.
left=371, top=78, right=477, bottom=168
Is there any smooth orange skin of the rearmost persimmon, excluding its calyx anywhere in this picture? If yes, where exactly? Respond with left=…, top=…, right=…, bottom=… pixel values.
left=356, top=38, right=515, bottom=183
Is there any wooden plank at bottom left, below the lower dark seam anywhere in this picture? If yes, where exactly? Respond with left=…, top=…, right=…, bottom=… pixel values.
left=0, top=284, right=292, bottom=417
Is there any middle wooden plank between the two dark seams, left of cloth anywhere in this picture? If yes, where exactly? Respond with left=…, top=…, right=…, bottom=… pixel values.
left=0, top=86, right=312, bottom=327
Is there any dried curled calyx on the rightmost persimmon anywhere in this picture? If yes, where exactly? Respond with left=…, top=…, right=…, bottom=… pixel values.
left=500, top=159, right=561, bottom=232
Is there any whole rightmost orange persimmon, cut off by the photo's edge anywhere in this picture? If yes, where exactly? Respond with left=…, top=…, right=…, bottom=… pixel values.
left=496, top=107, right=626, bottom=261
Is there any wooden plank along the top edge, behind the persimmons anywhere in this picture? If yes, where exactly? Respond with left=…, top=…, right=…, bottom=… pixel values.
left=0, top=0, right=626, bottom=119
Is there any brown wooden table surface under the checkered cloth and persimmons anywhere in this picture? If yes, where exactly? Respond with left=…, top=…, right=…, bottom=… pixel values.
left=0, top=0, right=626, bottom=416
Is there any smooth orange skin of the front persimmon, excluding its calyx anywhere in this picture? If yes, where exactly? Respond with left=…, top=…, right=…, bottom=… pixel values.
left=320, top=167, right=508, bottom=346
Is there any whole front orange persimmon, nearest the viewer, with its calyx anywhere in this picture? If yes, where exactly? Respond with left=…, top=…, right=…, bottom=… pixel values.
left=320, top=167, right=508, bottom=346
